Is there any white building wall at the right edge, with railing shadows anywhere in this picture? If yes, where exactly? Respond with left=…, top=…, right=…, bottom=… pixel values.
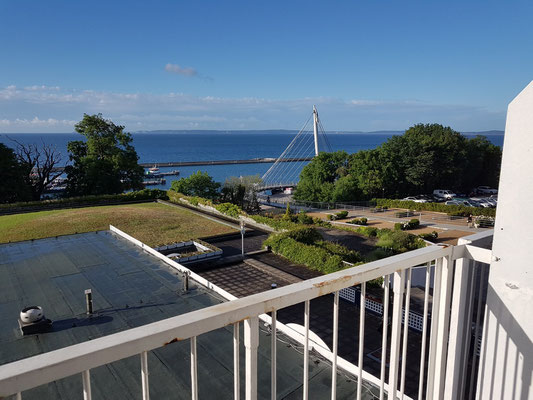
left=477, top=82, right=533, bottom=399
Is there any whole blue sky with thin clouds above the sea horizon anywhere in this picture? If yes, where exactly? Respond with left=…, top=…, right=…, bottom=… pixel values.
left=0, top=0, right=533, bottom=133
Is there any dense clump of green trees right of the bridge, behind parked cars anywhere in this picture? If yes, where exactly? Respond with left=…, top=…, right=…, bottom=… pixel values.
left=295, top=124, right=501, bottom=201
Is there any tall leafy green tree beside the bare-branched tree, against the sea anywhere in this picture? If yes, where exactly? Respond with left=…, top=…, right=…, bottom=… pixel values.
left=65, top=114, right=144, bottom=196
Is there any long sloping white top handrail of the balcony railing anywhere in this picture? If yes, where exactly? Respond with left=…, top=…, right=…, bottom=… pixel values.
left=0, top=242, right=453, bottom=396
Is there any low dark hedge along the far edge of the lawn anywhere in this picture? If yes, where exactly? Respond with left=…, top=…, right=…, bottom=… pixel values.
left=0, top=189, right=168, bottom=214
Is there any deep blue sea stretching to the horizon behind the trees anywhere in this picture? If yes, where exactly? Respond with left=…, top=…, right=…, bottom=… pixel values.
left=0, top=131, right=503, bottom=189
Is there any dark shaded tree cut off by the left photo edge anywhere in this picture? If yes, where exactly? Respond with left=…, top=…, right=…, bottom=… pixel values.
left=0, top=143, right=31, bottom=203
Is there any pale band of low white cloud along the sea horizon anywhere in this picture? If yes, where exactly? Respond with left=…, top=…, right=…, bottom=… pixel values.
left=0, top=85, right=505, bottom=133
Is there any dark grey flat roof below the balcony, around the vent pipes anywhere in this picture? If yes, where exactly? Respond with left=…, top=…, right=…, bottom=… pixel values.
left=0, top=231, right=378, bottom=400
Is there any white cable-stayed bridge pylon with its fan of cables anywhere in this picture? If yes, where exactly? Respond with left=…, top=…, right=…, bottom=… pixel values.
left=258, top=106, right=331, bottom=190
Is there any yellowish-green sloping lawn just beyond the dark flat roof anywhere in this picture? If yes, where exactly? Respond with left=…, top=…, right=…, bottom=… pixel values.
left=0, top=203, right=235, bottom=246
